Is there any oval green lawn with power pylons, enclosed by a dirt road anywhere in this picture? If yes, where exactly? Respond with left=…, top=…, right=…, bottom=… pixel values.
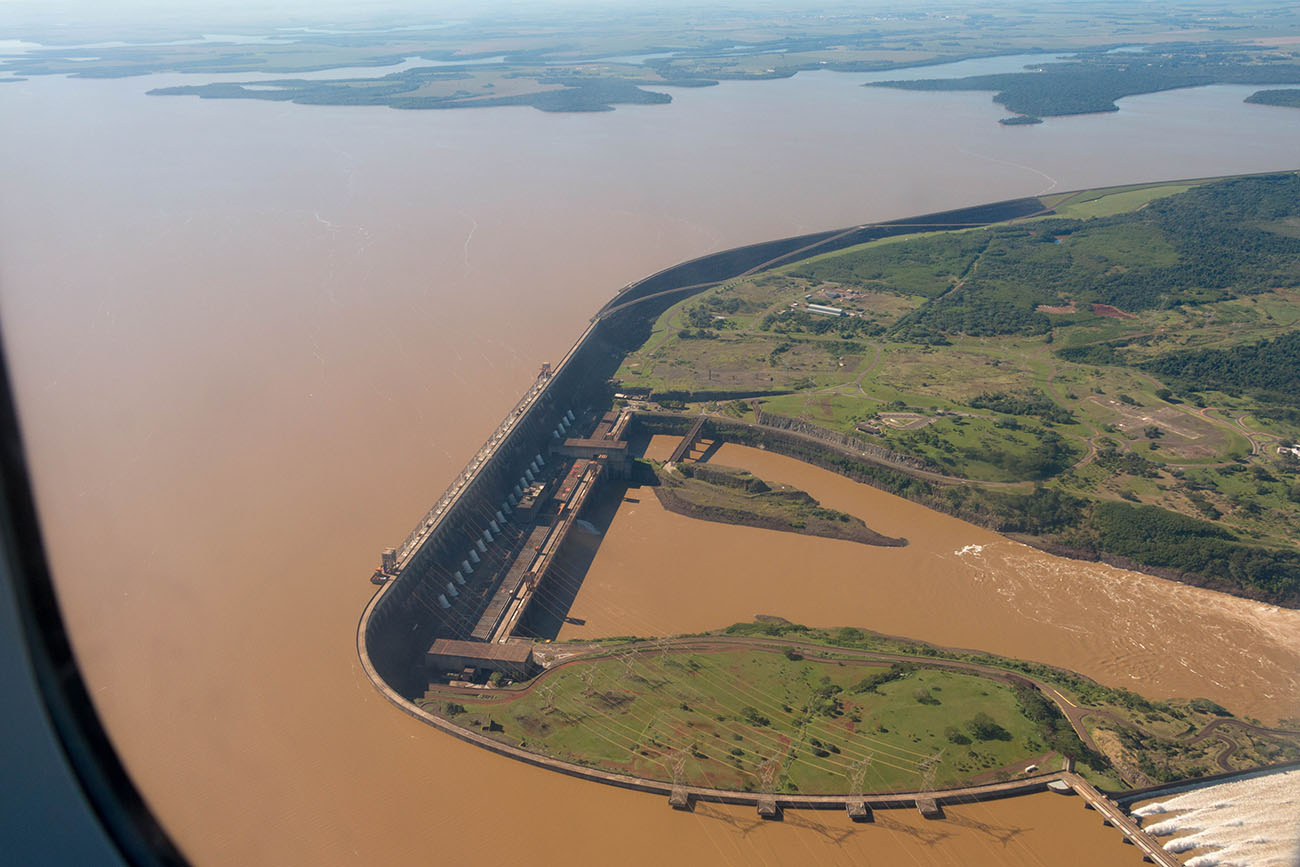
left=447, top=650, right=1047, bottom=793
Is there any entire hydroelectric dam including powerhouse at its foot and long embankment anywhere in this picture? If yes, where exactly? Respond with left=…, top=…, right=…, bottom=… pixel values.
left=358, top=198, right=1049, bottom=696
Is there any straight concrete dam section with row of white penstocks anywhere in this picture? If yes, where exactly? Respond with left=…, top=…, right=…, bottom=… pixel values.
left=359, top=313, right=634, bottom=699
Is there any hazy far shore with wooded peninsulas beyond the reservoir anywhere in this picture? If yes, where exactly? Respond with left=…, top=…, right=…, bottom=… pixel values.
left=10, top=3, right=1300, bottom=113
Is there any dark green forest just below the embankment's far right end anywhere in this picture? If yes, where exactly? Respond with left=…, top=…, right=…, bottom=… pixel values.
left=821, top=174, right=1300, bottom=340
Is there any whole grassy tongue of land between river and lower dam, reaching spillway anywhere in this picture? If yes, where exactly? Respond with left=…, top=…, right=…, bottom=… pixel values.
left=421, top=619, right=1300, bottom=794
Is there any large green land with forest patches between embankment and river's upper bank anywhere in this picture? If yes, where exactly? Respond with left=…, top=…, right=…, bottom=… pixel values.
left=618, top=173, right=1300, bottom=606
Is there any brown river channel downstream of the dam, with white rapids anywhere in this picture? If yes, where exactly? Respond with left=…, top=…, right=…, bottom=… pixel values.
left=560, top=437, right=1300, bottom=720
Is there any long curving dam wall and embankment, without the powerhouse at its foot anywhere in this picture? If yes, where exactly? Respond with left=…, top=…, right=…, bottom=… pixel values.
left=359, top=191, right=1044, bottom=699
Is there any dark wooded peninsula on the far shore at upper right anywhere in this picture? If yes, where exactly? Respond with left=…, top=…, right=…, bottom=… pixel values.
left=867, top=43, right=1300, bottom=118
